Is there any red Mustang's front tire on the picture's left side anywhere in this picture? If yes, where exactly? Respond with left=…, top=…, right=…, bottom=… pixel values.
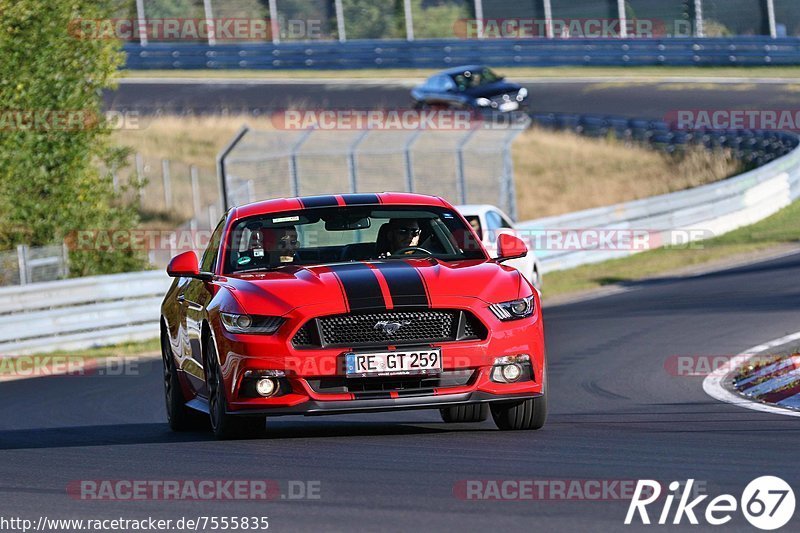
left=203, top=336, right=266, bottom=440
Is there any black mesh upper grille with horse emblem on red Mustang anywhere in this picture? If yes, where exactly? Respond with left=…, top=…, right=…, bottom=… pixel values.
left=292, top=309, right=486, bottom=348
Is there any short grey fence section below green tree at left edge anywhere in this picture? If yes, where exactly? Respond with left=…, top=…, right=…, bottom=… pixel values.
left=0, top=244, right=69, bottom=286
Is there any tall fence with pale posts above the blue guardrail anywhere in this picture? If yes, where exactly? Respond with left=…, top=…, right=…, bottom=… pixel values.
left=120, top=0, right=800, bottom=45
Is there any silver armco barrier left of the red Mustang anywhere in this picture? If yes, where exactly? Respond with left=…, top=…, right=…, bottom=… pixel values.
left=0, top=270, right=171, bottom=357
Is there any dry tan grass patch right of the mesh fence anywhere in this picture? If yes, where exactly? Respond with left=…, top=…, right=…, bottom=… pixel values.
left=513, top=129, right=742, bottom=220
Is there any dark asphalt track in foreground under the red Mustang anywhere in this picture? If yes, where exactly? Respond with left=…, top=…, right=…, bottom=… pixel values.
left=0, top=248, right=800, bottom=531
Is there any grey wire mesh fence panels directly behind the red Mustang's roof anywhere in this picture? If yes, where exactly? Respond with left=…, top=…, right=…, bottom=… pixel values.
left=220, top=116, right=530, bottom=217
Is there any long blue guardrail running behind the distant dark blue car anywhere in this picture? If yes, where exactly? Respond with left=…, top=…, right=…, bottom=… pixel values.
left=125, top=37, right=800, bottom=70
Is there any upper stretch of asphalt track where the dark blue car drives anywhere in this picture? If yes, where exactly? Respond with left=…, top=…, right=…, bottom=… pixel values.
left=105, top=80, right=800, bottom=118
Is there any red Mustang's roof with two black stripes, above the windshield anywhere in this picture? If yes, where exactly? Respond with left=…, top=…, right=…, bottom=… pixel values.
left=231, top=192, right=452, bottom=219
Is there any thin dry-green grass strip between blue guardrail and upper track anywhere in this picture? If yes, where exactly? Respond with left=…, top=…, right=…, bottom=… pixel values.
left=121, top=67, right=800, bottom=80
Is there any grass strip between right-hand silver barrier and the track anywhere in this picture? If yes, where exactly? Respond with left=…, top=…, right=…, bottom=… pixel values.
left=543, top=197, right=800, bottom=298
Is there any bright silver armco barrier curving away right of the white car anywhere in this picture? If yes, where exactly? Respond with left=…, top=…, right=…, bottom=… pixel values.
left=518, top=137, right=800, bottom=274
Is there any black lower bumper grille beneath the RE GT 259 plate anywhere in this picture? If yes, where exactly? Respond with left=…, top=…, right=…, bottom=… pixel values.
left=307, top=369, right=477, bottom=395
